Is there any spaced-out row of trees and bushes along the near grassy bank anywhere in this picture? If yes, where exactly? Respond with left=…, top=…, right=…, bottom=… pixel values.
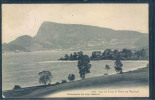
left=39, top=55, right=123, bottom=85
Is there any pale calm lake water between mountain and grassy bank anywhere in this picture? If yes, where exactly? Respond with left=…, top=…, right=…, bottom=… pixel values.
left=2, top=51, right=148, bottom=90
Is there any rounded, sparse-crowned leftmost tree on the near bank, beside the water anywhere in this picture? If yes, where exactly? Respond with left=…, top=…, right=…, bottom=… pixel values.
left=39, top=71, right=52, bottom=85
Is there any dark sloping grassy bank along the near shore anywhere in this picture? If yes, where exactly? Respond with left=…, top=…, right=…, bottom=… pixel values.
left=3, top=67, right=149, bottom=98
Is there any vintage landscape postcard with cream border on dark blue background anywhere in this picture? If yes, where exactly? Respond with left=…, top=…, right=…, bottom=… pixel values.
left=2, top=3, right=149, bottom=98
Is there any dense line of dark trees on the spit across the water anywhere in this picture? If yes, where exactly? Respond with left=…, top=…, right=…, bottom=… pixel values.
left=59, top=49, right=149, bottom=60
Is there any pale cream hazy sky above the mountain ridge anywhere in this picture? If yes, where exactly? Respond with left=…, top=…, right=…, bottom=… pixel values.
left=2, top=4, right=148, bottom=43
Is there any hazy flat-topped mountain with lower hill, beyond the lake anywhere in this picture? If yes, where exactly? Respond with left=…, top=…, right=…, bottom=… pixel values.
left=2, top=21, right=148, bottom=51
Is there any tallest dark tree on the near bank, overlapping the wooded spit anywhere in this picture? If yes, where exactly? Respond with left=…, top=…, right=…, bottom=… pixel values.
left=77, top=55, right=91, bottom=79
